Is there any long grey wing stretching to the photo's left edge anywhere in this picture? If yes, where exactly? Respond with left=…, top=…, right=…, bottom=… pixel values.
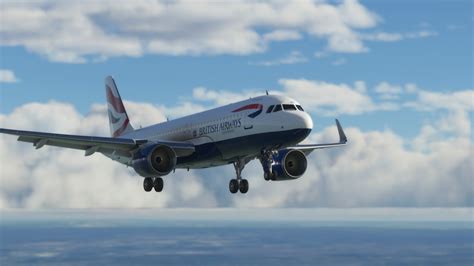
left=0, top=128, right=194, bottom=157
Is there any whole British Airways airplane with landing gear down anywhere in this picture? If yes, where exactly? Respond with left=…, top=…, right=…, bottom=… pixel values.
left=0, top=76, right=347, bottom=194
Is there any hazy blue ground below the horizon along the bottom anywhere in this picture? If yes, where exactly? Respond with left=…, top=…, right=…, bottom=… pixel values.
left=0, top=208, right=474, bottom=265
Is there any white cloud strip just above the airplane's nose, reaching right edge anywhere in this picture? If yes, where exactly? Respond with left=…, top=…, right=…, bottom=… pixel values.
left=191, top=79, right=474, bottom=116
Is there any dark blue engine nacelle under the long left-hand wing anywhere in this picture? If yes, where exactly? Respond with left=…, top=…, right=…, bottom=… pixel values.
left=132, top=144, right=176, bottom=177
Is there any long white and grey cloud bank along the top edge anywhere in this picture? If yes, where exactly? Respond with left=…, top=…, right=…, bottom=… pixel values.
left=0, top=0, right=380, bottom=63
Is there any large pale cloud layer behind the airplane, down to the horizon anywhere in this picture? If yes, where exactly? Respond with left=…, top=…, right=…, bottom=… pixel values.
left=0, top=85, right=474, bottom=208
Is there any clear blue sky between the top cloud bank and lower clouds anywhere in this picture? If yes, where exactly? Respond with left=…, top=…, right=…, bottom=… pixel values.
left=1, top=1, right=473, bottom=137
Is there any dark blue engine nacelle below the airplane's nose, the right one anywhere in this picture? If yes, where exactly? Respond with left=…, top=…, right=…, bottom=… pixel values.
left=271, top=150, right=308, bottom=181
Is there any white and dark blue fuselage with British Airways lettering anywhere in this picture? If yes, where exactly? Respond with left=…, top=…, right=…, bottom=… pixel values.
left=116, top=95, right=313, bottom=168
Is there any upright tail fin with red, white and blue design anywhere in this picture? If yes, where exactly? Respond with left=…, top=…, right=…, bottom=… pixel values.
left=105, top=76, right=133, bottom=138
